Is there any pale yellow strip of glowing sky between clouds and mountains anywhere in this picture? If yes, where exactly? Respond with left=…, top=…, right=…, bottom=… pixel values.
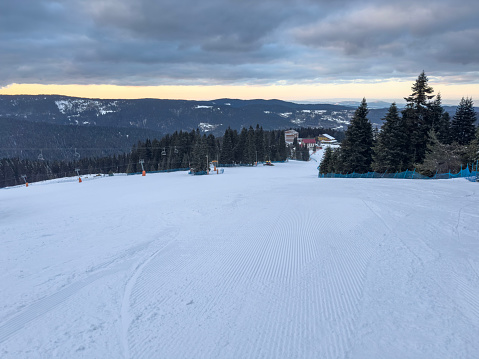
left=0, top=80, right=479, bottom=101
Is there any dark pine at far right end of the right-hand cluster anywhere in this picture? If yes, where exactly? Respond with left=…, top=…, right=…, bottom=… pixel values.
left=451, top=97, right=476, bottom=145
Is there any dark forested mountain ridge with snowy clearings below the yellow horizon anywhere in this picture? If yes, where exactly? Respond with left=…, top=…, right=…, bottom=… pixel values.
left=0, top=95, right=476, bottom=160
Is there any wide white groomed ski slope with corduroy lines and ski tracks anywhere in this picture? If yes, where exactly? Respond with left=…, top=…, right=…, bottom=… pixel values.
left=0, top=153, right=479, bottom=359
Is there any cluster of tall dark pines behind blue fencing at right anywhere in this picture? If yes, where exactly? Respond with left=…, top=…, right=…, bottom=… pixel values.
left=320, top=71, right=479, bottom=176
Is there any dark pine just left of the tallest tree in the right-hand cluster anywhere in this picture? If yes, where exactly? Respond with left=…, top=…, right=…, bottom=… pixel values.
left=373, top=103, right=409, bottom=172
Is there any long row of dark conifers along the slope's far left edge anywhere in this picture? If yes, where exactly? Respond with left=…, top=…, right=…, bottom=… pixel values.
left=0, top=125, right=298, bottom=187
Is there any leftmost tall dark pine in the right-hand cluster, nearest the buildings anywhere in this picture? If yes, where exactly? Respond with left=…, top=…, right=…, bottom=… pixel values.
left=341, top=99, right=373, bottom=173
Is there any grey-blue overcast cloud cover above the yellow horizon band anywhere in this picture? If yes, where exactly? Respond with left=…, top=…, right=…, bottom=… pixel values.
left=0, top=0, right=479, bottom=98
